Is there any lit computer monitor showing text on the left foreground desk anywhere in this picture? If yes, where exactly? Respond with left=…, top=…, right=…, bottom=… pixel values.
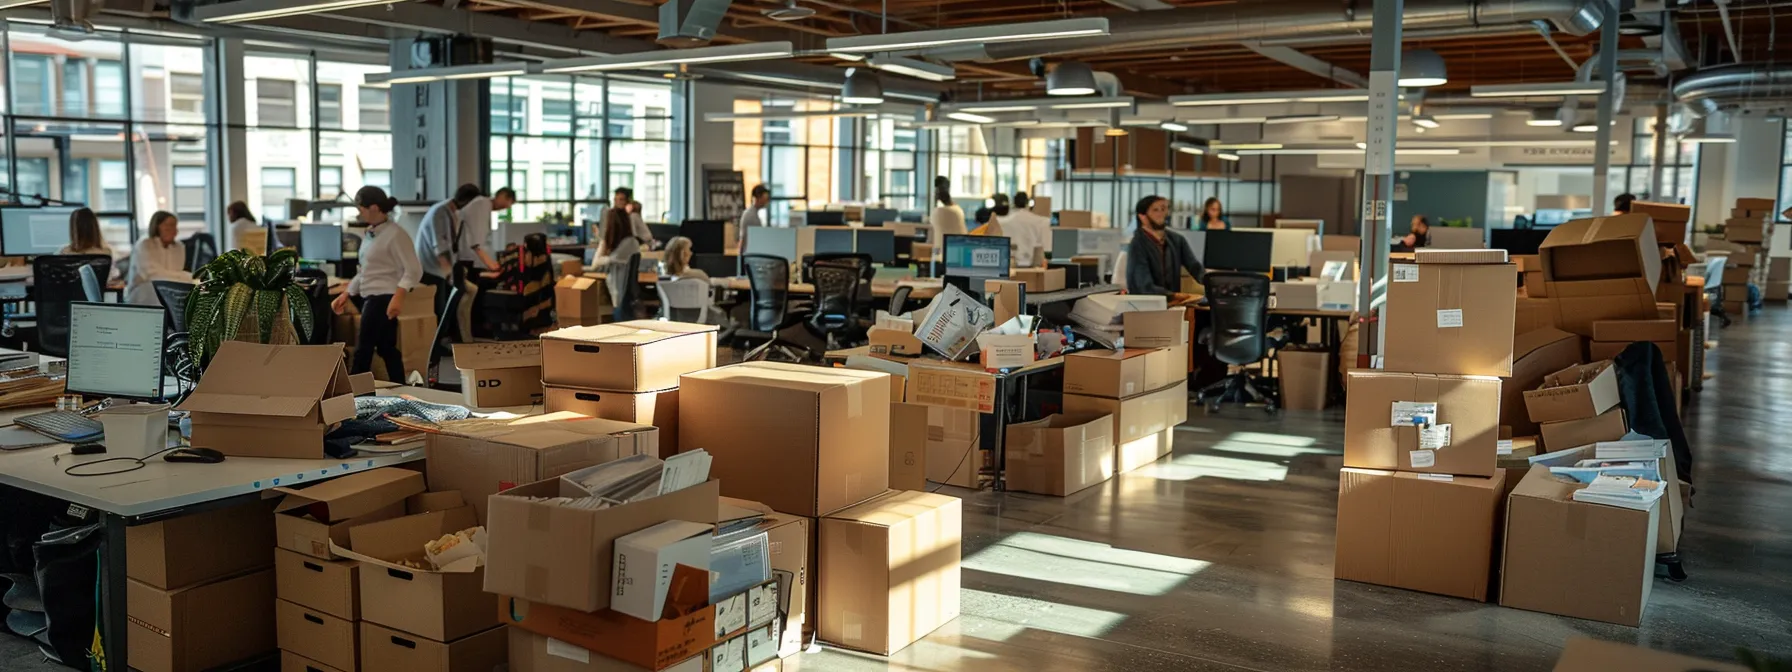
left=66, top=301, right=163, bottom=400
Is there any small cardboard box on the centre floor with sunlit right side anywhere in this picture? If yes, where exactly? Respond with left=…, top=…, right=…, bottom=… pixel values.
left=1004, top=414, right=1115, bottom=496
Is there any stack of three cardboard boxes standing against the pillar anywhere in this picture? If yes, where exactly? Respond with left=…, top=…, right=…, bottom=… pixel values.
left=1335, top=251, right=1518, bottom=600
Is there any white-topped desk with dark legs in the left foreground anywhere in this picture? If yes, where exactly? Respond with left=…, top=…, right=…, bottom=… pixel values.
left=0, top=360, right=534, bottom=670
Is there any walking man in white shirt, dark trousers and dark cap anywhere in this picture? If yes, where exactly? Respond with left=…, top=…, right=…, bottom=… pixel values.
left=330, top=186, right=423, bottom=383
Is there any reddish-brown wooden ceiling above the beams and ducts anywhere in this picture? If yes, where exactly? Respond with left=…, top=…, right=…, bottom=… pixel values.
left=451, top=0, right=1792, bottom=99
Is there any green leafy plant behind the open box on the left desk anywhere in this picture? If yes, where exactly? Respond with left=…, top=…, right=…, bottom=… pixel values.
left=186, top=247, right=314, bottom=366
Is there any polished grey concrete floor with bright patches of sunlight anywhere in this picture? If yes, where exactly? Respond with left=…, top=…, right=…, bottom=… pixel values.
left=0, top=305, right=1792, bottom=672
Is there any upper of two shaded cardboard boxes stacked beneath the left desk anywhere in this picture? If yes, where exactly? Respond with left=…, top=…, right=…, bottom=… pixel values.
left=125, top=500, right=274, bottom=590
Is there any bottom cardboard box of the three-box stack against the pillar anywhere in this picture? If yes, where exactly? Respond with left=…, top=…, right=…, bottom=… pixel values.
left=1335, top=468, right=1505, bottom=600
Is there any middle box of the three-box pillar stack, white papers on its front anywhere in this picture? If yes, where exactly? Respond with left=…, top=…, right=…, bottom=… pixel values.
left=1344, top=369, right=1500, bottom=477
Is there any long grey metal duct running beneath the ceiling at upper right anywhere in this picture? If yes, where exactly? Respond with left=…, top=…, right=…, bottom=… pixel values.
left=928, top=0, right=1607, bottom=61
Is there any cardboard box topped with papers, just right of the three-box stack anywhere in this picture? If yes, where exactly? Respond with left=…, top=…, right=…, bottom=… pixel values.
left=1500, top=469, right=1661, bottom=627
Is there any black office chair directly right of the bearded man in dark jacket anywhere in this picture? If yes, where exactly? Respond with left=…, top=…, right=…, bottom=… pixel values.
left=1195, top=271, right=1278, bottom=414
